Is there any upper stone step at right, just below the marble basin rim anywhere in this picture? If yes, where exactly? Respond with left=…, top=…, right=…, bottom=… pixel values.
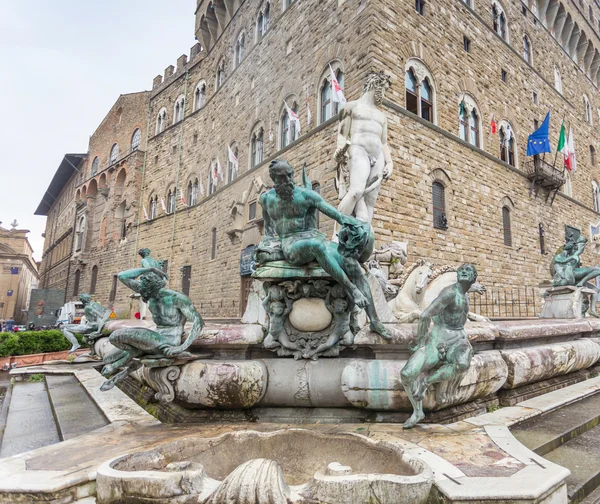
left=510, top=393, right=600, bottom=456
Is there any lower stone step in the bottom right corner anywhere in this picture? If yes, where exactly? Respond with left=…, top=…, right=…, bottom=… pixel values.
left=544, top=426, right=600, bottom=504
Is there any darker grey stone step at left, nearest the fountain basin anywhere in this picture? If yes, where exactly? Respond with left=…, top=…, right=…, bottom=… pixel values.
left=46, top=375, right=109, bottom=441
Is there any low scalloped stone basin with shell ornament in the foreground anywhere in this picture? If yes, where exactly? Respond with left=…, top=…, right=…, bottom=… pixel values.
left=97, top=429, right=433, bottom=504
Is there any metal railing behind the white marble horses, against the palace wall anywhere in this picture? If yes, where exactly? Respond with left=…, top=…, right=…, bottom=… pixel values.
left=469, top=287, right=542, bottom=318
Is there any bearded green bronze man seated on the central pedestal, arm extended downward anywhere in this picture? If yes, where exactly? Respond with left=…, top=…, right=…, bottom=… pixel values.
left=256, top=160, right=390, bottom=338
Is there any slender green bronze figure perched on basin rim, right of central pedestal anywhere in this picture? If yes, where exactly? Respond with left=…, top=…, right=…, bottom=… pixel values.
left=401, top=264, right=477, bottom=429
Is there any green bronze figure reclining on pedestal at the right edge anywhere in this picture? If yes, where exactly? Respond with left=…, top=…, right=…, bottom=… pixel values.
left=552, top=226, right=600, bottom=317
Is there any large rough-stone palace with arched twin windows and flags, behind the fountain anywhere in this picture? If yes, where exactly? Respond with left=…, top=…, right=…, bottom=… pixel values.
left=39, top=0, right=600, bottom=317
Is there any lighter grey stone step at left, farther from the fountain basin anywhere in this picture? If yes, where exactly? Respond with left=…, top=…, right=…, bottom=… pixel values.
left=0, top=381, right=60, bottom=458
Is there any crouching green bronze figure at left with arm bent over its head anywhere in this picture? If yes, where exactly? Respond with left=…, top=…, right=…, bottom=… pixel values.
left=101, top=266, right=204, bottom=390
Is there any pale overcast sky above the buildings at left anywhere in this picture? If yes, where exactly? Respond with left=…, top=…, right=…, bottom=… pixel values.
left=0, top=0, right=196, bottom=260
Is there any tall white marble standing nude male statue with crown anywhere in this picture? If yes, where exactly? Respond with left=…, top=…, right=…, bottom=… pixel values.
left=334, top=72, right=393, bottom=224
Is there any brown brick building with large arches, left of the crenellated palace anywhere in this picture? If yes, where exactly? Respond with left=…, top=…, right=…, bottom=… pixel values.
left=38, top=91, right=150, bottom=311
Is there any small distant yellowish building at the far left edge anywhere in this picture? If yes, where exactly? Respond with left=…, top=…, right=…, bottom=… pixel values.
left=0, top=223, right=39, bottom=324
